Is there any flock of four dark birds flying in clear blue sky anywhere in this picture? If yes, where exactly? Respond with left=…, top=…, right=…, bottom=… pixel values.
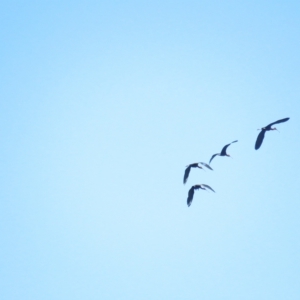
left=183, top=118, right=290, bottom=206
